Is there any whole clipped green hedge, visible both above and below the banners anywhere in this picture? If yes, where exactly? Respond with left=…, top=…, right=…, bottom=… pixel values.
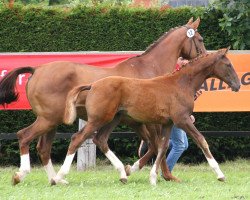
left=0, top=6, right=250, bottom=165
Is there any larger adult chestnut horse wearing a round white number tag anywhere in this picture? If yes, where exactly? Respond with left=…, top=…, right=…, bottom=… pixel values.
left=0, top=19, right=206, bottom=184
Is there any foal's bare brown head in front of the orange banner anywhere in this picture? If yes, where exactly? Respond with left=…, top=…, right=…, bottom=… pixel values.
left=212, top=47, right=240, bottom=92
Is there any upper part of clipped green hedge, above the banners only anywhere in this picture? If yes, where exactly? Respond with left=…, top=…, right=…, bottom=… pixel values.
left=0, top=6, right=233, bottom=52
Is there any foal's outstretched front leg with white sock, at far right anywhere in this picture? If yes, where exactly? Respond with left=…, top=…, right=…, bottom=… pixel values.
left=177, top=116, right=225, bottom=181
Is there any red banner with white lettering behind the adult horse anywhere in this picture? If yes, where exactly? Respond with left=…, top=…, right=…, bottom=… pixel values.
left=0, top=53, right=138, bottom=110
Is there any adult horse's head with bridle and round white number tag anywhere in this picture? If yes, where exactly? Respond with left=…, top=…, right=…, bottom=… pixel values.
left=181, top=18, right=207, bottom=59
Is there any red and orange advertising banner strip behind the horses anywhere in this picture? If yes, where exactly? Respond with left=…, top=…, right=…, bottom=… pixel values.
left=0, top=51, right=250, bottom=112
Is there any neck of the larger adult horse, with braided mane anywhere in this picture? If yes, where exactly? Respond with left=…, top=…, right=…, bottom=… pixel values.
left=117, top=30, right=186, bottom=77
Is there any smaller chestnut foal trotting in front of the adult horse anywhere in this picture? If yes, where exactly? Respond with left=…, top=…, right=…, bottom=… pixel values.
left=52, top=49, right=240, bottom=185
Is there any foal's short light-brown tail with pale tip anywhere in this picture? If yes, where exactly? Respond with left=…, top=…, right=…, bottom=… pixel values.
left=63, top=85, right=91, bottom=124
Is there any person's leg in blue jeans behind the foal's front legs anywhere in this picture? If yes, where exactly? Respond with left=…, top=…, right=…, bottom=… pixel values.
left=166, top=126, right=188, bottom=171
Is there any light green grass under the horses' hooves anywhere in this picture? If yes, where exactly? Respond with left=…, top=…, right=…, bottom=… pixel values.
left=0, top=160, right=250, bottom=200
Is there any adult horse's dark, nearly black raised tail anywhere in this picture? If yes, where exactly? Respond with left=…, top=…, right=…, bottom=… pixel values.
left=0, top=67, right=35, bottom=107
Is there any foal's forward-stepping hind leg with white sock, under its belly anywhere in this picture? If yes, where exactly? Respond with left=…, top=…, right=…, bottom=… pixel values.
left=93, top=114, right=127, bottom=183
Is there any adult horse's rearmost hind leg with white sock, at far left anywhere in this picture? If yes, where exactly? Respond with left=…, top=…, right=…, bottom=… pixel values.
left=12, top=117, right=53, bottom=185
